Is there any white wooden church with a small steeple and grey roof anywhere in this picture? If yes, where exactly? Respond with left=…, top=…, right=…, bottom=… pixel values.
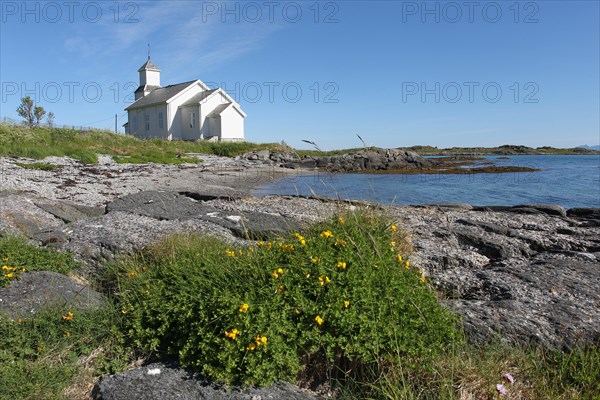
left=123, top=54, right=246, bottom=141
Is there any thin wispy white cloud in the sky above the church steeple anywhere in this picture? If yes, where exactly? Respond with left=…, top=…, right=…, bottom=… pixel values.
left=64, top=1, right=280, bottom=71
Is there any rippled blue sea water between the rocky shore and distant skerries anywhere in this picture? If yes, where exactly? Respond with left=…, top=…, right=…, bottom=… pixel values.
left=255, top=155, right=600, bottom=208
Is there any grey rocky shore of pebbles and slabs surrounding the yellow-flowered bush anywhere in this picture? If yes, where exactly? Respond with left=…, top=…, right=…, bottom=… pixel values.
left=0, top=155, right=600, bottom=399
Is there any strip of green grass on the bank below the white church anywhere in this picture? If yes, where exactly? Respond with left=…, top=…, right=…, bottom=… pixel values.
left=0, top=124, right=281, bottom=164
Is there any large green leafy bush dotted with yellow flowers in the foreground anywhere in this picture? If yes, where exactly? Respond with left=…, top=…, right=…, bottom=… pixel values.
left=113, top=213, right=459, bottom=385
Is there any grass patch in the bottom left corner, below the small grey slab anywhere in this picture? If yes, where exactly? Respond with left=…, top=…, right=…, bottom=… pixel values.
left=0, top=306, right=133, bottom=400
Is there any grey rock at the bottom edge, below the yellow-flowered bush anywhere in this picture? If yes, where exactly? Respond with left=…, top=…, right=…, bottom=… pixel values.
left=92, top=363, right=317, bottom=400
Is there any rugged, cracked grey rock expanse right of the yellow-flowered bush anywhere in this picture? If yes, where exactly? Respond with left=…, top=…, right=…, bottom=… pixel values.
left=395, top=205, right=600, bottom=349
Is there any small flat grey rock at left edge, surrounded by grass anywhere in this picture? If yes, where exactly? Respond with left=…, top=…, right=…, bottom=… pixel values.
left=0, top=271, right=105, bottom=318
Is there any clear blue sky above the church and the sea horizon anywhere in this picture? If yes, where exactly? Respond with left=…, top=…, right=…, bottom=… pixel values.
left=0, top=0, right=600, bottom=149
